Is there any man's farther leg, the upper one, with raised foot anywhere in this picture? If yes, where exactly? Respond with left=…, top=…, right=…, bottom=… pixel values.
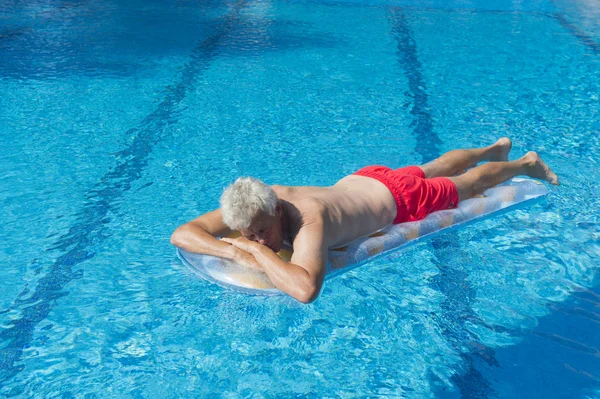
left=420, top=137, right=512, bottom=178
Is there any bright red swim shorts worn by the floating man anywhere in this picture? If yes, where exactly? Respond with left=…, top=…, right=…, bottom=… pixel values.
left=354, top=166, right=458, bottom=224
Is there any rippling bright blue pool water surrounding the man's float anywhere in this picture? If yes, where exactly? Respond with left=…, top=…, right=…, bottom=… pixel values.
left=0, top=0, right=600, bottom=398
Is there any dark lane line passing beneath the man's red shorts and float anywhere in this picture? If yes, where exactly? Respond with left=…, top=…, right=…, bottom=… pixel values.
left=390, top=9, right=498, bottom=399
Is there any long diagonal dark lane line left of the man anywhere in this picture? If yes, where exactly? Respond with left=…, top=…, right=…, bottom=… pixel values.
left=0, top=0, right=247, bottom=386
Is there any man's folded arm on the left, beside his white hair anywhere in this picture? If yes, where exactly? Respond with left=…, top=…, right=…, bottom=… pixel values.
left=171, top=209, right=260, bottom=270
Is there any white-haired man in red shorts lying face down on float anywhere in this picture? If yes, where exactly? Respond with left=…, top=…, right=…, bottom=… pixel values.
left=171, top=137, right=558, bottom=303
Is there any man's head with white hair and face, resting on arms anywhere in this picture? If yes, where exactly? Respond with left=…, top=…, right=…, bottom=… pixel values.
left=221, top=177, right=283, bottom=252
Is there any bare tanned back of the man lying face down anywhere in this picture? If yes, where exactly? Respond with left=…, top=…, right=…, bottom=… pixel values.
left=272, top=175, right=396, bottom=248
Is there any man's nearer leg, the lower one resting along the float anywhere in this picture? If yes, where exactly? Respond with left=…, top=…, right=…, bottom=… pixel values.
left=449, top=151, right=559, bottom=201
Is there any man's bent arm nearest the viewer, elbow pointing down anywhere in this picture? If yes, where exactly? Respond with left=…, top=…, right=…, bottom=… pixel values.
left=222, top=223, right=327, bottom=303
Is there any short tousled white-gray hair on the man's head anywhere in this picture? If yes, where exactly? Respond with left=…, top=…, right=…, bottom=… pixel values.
left=221, top=177, right=277, bottom=230
